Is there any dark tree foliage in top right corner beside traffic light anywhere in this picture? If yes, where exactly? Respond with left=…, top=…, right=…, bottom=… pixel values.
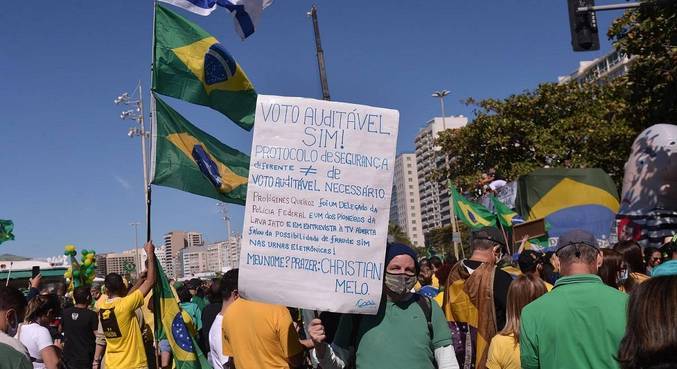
left=607, top=1, right=677, bottom=130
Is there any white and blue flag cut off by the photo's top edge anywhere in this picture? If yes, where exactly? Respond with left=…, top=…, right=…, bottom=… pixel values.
left=160, top=0, right=273, bottom=40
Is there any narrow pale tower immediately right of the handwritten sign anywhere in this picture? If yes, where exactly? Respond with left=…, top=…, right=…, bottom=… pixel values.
left=390, top=153, right=425, bottom=247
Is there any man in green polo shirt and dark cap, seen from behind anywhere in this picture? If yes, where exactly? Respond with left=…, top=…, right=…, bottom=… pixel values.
left=520, top=230, right=628, bottom=369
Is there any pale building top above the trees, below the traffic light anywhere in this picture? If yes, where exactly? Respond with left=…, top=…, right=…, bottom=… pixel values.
left=558, top=50, right=633, bottom=85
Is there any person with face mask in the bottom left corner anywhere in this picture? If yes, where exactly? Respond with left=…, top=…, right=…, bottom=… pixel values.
left=0, top=286, right=33, bottom=369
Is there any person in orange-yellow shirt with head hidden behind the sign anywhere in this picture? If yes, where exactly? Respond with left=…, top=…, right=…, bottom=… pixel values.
left=221, top=268, right=312, bottom=369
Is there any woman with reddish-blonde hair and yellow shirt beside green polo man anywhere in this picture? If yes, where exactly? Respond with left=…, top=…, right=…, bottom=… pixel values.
left=487, top=275, right=546, bottom=369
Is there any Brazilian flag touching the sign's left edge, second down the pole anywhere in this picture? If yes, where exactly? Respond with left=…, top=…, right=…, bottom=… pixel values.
left=151, top=92, right=249, bottom=205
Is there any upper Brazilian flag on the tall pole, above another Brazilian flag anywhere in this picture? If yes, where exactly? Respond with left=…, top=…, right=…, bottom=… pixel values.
left=153, top=5, right=256, bottom=130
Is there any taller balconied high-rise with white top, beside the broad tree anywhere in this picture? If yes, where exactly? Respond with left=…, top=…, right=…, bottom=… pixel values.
left=414, top=115, right=468, bottom=235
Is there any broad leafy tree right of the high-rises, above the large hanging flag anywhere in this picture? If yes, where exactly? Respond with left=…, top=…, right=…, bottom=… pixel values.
left=436, top=83, right=637, bottom=188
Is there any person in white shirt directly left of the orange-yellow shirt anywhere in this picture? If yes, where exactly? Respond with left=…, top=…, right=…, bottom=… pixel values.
left=208, top=269, right=238, bottom=369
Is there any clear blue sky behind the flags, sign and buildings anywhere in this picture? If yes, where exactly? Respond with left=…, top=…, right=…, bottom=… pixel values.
left=0, top=0, right=620, bottom=257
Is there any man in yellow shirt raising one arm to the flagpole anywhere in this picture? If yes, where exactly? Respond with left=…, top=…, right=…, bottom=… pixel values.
left=93, top=242, right=156, bottom=369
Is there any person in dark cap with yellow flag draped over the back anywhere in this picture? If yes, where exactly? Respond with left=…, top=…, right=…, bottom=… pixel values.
left=442, top=227, right=512, bottom=368
